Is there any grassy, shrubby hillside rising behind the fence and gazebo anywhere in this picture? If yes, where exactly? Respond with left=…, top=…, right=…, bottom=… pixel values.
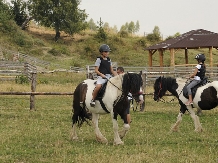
left=0, top=23, right=218, bottom=69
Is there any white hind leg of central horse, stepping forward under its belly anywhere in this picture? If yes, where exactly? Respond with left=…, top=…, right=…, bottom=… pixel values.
left=92, top=113, right=108, bottom=144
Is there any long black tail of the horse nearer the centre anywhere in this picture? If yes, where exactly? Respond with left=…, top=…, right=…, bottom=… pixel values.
left=72, top=83, right=92, bottom=127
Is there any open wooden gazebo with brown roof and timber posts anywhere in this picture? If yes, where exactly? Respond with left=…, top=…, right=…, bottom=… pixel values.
left=145, top=29, right=218, bottom=67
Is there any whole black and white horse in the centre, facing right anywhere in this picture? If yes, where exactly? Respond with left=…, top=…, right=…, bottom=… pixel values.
left=71, top=73, right=143, bottom=145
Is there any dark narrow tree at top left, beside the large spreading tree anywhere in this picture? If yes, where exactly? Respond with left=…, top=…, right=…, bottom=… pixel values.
left=10, top=0, right=27, bottom=26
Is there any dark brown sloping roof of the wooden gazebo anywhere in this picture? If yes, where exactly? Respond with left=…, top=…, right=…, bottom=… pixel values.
left=145, top=29, right=218, bottom=50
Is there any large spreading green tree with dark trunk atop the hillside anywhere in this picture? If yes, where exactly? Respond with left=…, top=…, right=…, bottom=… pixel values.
left=28, top=0, right=87, bottom=41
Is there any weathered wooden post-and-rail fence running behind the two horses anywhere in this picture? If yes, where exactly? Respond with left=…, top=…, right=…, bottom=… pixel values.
left=0, top=63, right=218, bottom=111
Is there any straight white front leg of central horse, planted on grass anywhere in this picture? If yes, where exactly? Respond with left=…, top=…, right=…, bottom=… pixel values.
left=111, top=113, right=123, bottom=145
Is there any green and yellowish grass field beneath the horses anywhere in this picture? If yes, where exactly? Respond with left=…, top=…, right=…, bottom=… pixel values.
left=0, top=74, right=218, bottom=163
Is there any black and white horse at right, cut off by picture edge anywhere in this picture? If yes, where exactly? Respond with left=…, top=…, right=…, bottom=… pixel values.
left=154, top=77, right=218, bottom=132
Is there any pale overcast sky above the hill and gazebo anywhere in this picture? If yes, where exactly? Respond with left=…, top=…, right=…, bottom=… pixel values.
left=79, top=0, right=218, bottom=38
